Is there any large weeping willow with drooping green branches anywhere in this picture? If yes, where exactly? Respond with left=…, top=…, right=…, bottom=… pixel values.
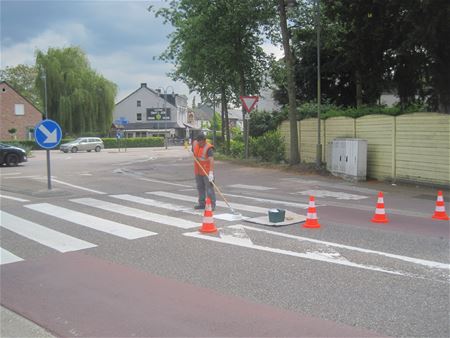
left=36, top=47, right=117, bottom=135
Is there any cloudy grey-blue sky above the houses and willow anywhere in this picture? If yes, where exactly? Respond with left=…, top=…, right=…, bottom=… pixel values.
left=0, top=0, right=281, bottom=105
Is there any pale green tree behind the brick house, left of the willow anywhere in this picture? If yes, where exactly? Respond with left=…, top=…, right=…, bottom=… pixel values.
left=0, top=64, right=43, bottom=110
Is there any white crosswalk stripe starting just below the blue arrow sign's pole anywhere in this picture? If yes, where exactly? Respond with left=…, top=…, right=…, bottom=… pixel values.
left=26, top=203, right=157, bottom=239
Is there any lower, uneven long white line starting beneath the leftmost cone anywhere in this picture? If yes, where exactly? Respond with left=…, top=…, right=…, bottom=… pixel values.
left=183, top=226, right=405, bottom=276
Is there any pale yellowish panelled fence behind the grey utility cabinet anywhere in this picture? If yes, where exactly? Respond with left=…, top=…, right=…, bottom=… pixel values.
left=280, top=113, right=450, bottom=187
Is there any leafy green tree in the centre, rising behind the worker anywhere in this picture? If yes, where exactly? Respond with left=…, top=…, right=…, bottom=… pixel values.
left=155, top=0, right=270, bottom=151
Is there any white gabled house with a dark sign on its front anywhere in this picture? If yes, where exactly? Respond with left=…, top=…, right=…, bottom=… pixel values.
left=113, top=83, right=187, bottom=138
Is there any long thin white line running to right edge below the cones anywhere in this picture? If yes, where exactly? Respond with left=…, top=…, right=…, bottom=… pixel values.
left=229, top=225, right=450, bottom=270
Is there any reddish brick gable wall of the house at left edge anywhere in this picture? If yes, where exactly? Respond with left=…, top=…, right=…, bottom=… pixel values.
left=0, top=82, right=42, bottom=140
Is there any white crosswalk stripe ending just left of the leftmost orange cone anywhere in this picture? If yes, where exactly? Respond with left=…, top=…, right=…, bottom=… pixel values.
left=71, top=198, right=200, bottom=229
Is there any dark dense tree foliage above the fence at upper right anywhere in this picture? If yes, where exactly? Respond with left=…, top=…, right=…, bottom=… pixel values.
left=272, top=0, right=450, bottom=112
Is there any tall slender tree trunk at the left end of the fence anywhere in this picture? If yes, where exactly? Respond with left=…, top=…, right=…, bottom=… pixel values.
left=279, top=0, right=300, bottom=165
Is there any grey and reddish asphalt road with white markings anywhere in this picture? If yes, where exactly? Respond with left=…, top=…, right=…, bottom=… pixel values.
left=0, top=147, right=450, bottom=337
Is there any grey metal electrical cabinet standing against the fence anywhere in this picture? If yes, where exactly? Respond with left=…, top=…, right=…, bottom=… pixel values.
left=327, top=138, right=367, bottom=181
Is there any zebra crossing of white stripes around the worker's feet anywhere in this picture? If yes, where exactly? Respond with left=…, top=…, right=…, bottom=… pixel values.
left=0, top=191, right=267, bottom=265
